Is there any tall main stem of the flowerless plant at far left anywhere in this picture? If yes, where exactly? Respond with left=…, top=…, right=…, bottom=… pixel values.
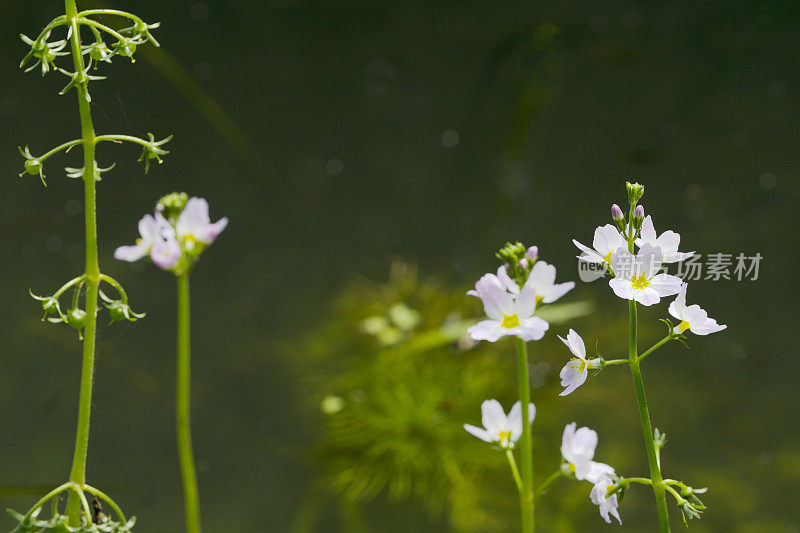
left=64, top=0, right=100, bottom=526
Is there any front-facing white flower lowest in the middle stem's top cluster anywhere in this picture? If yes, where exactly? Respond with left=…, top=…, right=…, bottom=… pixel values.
left=467, top=267, right=550, bottom=342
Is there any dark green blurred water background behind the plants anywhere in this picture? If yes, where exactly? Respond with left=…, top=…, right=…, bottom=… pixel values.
left=0, top=0, right=800, bottom=533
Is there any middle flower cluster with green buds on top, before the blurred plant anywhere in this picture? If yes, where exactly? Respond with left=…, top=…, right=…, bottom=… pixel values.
left=467, top=243, right=575, bottom=342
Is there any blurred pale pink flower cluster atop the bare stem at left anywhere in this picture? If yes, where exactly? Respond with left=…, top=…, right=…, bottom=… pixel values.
left=114, top=193, right=228, bottom=275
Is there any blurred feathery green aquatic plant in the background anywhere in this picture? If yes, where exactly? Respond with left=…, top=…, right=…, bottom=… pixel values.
left=296, top=262, right=592, bottom=532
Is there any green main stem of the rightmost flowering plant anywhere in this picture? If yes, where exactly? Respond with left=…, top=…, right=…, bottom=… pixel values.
left=628, top=300, right=670, bottom=533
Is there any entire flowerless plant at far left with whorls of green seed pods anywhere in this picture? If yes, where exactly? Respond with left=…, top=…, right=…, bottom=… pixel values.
left=10, top=0, right=169, bottom=533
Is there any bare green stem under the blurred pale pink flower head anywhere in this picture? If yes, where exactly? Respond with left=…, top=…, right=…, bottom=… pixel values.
left=175, top=273, right=200, bottom=533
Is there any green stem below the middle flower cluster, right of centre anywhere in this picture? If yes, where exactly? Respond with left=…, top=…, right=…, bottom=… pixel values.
left=517, top=337, right=535, bottom=533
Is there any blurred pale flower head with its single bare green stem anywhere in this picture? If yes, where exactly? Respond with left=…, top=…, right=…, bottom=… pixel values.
left=114, top=193, right=228, bottom=533
